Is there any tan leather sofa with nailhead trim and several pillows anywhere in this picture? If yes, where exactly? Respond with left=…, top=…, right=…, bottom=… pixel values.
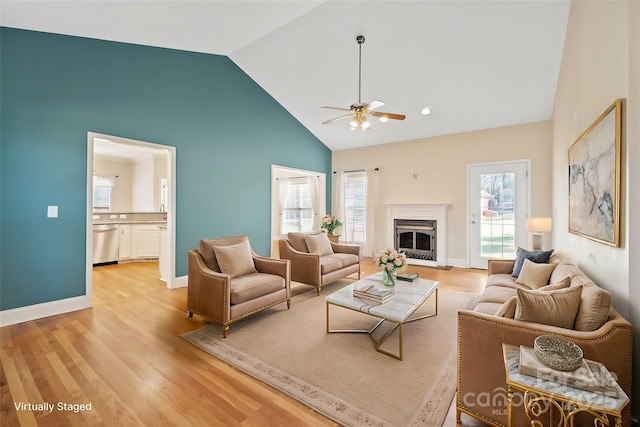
left=456, top=255, right=637, bottom=426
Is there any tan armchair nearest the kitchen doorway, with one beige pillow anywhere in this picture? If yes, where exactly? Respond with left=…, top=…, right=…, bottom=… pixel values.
left=187, top=236, right=291, bottom=338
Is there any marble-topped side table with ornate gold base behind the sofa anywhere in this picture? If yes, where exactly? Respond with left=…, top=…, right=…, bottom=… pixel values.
left=502, top=344, right=629, bottom=427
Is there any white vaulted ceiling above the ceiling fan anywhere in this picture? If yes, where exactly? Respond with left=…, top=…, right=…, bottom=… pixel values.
left=0, top=0, right=570, bottom=150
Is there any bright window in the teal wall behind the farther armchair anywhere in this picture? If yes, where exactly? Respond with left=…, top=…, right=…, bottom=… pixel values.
left=281, top=178, right=314, bottom=234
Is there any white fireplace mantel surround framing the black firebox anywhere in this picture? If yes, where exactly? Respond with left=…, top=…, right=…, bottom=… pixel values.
left=385, top=203, right=451, bottom=266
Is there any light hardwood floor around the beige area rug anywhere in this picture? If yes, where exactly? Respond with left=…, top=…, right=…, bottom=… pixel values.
left=0, top=259, right=486, bottom=426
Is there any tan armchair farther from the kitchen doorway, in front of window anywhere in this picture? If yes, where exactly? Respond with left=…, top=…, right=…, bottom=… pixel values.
left=279, top=231, right=360, bottom=295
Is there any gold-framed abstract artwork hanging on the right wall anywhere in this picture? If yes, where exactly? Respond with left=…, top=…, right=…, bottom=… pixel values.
left=569, top=99, right=622, bottom=247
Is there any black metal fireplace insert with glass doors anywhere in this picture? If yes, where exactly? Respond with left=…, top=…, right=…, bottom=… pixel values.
left=394, top=219, right=438, bottom=261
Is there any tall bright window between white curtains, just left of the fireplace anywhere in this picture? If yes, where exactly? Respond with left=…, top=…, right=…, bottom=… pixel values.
left=342, top=171, right=367, bottom=243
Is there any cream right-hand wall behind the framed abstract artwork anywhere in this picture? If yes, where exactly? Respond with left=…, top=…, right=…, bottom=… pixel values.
left=552, top=0, right=640, bottom=417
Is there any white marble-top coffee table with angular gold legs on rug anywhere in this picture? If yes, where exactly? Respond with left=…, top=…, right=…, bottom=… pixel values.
left=325, top=272, right=439, bottom=360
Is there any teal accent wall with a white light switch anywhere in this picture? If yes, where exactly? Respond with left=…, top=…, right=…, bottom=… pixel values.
left=0, top=28, right=331, bottom=310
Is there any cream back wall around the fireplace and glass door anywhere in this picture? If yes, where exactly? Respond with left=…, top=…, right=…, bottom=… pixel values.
left=333, top=121, right=551, bottom=266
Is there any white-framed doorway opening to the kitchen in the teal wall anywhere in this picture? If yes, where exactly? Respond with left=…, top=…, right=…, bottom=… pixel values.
left=85, top=132, right=176, bottom=301
